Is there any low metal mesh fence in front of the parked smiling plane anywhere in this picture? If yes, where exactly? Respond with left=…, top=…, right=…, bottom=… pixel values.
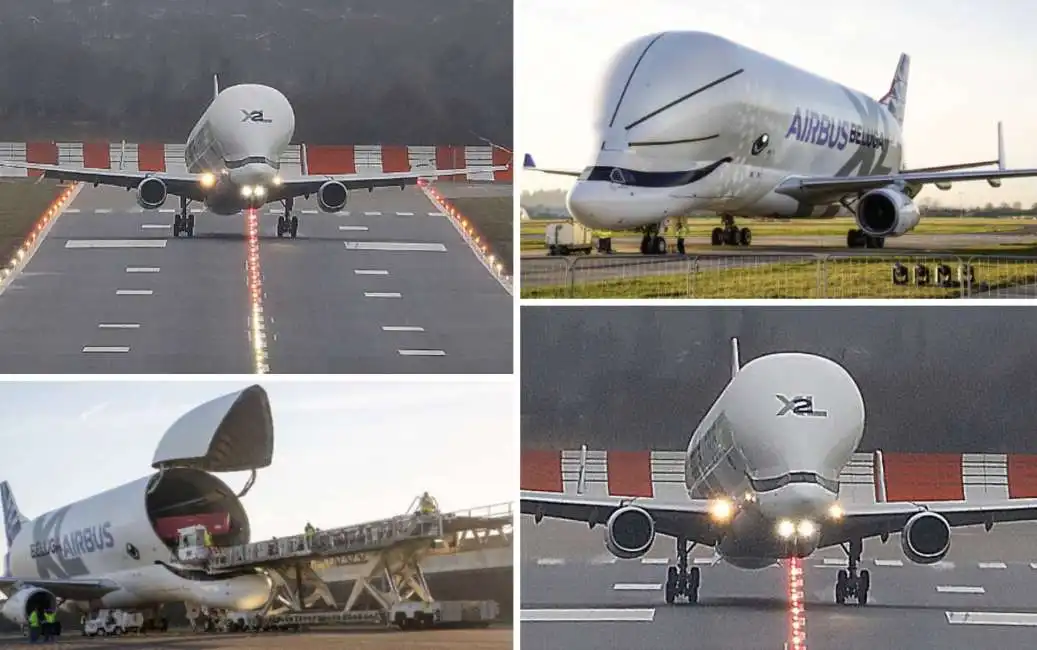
left=521, top=251, right=1037, bottom=299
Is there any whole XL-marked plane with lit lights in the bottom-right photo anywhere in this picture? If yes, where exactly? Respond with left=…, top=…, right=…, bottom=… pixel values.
left=521, top=339, right=1037, bottom=605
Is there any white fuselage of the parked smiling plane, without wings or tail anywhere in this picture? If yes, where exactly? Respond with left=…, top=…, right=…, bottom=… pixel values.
left=566, top=32, right=903, bottom=229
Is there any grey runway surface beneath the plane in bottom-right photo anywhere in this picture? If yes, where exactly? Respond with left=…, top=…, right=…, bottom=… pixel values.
left=521, top=517, right=1037, bottom=650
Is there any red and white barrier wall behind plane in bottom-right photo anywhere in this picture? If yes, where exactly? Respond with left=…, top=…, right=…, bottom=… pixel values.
left=522, top=449, right=1037, bottom=503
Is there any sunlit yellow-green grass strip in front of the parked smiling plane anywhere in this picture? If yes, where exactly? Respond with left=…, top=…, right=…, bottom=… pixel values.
left=522, top=258, right=1037, bottom=299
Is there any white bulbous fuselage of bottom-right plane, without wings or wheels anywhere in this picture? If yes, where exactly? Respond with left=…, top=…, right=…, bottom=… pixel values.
left=685, top=352, right=864, bottom=568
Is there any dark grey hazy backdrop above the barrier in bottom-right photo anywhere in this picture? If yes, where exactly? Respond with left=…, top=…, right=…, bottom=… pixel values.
left=521, top=305, right=1037, bottom=453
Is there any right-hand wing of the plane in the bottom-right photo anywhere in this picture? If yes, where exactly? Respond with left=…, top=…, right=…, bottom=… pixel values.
left=820, top=499, right=1037, bottom=547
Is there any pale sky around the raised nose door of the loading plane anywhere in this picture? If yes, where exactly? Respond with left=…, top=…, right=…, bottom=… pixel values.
left=0, top=379, right=519, bottom=554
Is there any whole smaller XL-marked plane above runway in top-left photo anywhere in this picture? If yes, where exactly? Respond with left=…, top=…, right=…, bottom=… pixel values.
left=0, top=76, right=507, bottom=238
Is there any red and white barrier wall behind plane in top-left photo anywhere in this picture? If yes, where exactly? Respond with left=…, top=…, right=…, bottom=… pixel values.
left=0, top=142, right=512, bottom=182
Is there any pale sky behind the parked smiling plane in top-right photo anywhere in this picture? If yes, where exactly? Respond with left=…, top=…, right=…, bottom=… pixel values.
left=515, top=0, right=1037, bottom=206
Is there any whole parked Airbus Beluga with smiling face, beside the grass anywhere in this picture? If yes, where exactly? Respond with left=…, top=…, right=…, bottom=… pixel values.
left=524, top=31, right=1037, bottom=255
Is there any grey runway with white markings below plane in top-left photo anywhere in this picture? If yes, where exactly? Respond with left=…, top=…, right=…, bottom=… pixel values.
left=0, top=188, right=513, bottom=373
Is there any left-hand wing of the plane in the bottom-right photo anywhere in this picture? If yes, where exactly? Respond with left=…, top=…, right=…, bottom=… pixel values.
left=521, top=491, right=719, bottom=546
